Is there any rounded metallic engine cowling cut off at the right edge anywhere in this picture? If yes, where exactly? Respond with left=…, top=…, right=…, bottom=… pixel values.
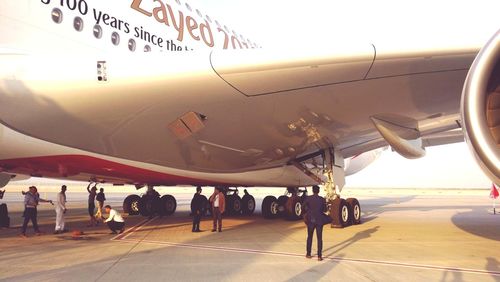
left=461, top=30, right=500, bottom=184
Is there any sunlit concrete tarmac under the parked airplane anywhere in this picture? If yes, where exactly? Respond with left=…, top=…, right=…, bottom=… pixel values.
left=0, top=187, right=500, bottom=281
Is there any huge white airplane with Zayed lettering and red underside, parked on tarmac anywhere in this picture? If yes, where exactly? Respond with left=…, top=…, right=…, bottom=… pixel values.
left=0, top=0, right=500, bottom=226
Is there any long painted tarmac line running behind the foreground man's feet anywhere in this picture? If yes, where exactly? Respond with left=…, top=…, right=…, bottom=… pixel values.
left=116, top=239, right=500, bottom=277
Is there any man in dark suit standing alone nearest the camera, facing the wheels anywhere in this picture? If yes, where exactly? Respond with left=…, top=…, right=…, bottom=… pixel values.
left=304, top=185, right=326, bottom=261
